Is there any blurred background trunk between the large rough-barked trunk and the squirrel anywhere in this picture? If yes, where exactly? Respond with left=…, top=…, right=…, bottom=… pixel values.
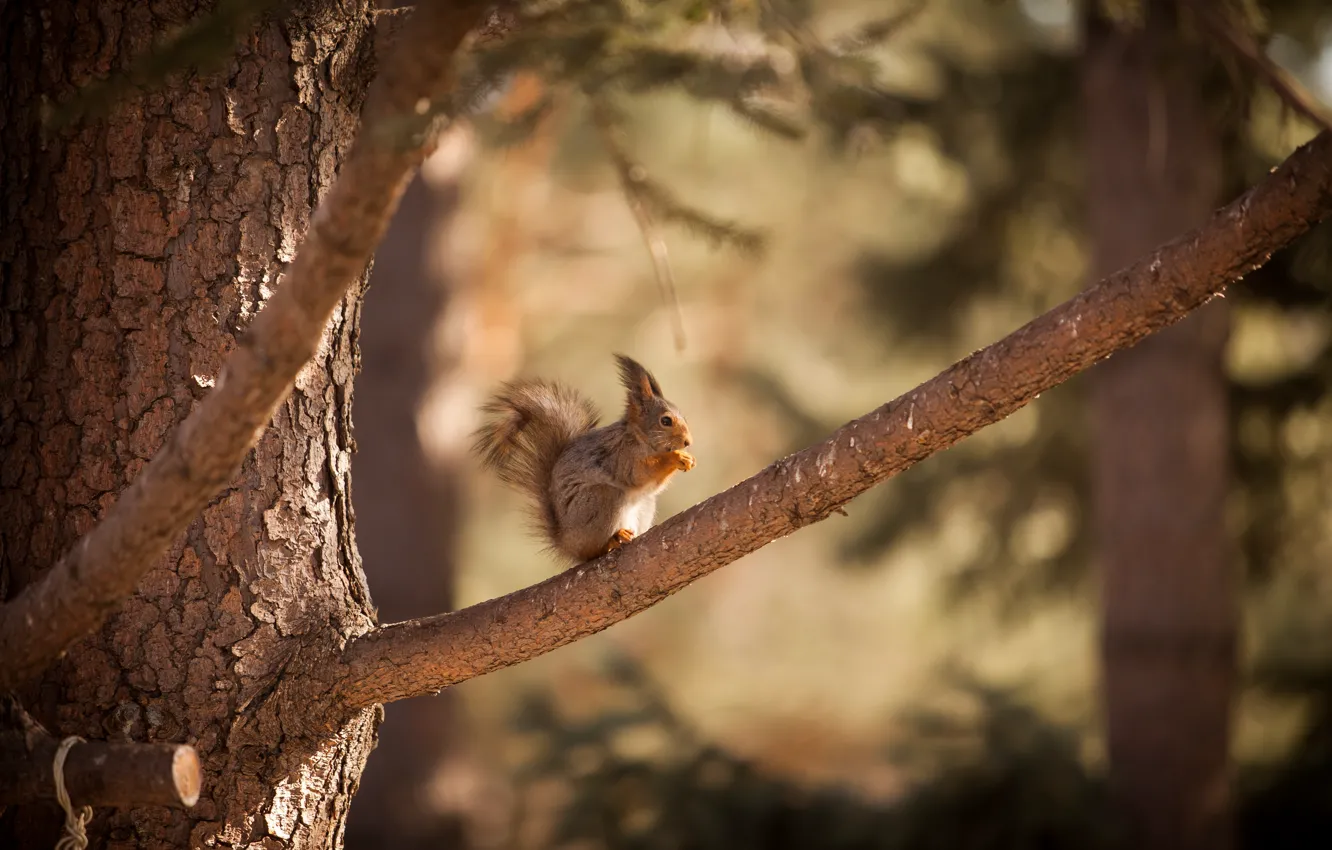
left=348, top=129, right=484, bottom=850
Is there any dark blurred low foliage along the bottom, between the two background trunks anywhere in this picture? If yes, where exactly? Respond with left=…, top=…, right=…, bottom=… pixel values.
left=503, top=657, right=1115, bottom=850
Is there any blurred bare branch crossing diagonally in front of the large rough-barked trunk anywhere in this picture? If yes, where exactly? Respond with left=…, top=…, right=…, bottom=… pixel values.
left=0, top=0, right=486, bottom=691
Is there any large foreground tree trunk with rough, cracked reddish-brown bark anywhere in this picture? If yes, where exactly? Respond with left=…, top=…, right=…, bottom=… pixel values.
left=0, top=0, right=378, bottom=847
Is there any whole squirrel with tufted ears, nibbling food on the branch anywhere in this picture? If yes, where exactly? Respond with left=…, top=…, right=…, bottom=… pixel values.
left=474, top=354, right=694, bottom=564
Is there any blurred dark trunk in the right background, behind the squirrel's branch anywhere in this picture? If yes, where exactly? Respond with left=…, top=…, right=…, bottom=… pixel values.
left=1084, top=3, right=1236, bottom=850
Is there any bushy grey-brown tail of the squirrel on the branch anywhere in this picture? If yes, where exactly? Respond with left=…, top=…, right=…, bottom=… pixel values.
left=474, top=380, right=601, bottom=536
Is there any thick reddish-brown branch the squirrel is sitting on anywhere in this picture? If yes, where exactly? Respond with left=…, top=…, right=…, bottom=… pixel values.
left=330, top=133, right=1332, bottom=710
